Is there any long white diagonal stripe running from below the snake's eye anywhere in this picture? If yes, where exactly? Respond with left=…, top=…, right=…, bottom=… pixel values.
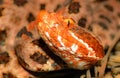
left=70, top=32, right=96, bottom=58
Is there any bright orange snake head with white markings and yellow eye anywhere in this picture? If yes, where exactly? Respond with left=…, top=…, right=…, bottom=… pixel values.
left=37, top=11, right=104, bottom=70
